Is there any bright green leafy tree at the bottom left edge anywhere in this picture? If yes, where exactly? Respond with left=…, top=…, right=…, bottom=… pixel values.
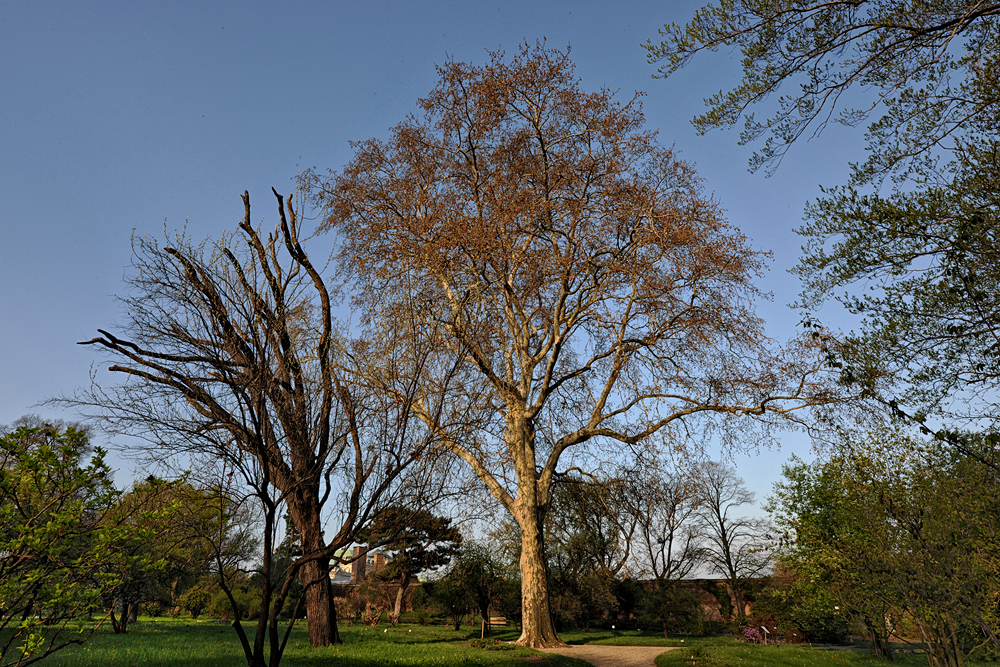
left=0, top=420, right=138, bottom=665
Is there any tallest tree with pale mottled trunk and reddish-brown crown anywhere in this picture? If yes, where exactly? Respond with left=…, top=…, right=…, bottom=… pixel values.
left=312, top=45, right=831, bottom=647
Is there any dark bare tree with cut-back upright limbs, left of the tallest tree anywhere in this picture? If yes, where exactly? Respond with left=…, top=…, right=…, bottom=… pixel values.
left=75, top=192, right=456, bottom=659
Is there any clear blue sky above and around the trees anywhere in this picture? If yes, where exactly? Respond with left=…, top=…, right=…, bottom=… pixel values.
left=0, top=0, right=862, bottom=495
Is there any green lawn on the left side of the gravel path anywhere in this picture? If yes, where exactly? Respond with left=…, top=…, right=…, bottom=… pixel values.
left=27, top=618, right=587, bottom=667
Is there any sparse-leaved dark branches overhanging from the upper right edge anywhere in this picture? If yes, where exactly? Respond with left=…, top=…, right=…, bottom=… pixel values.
left=646, top=0, right=1000, bottom=448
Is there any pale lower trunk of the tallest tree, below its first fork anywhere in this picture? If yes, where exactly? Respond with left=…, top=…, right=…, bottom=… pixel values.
left=516, top=508, right=566, bottom=648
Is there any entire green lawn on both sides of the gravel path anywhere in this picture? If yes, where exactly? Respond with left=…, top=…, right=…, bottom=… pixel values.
left=21, top=618, right=995, bottom=667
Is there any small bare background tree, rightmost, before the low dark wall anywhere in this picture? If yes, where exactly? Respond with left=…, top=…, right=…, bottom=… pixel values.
left=695, top=461, right=771, bottom=617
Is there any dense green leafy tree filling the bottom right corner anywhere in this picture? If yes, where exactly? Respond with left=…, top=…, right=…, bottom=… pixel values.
left=772, top=432, right=1000, bottom=667
